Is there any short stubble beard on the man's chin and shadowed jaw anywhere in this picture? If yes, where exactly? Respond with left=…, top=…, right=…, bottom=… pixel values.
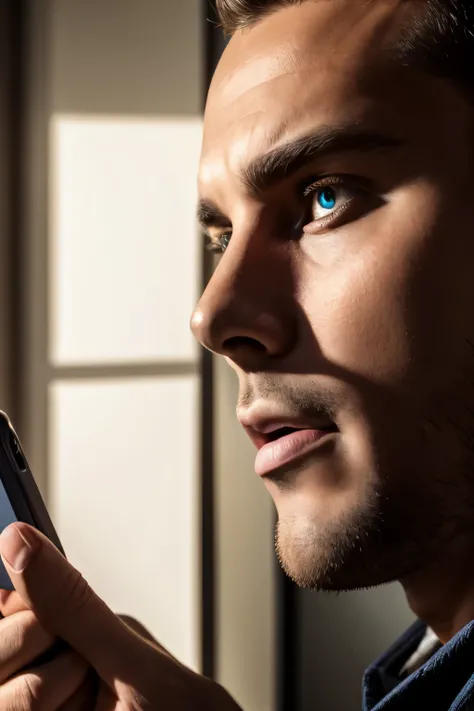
left=275, top=464, right=457, bottom=592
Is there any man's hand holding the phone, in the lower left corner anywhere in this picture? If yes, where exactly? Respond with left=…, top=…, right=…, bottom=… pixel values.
left=0, top=523, right=239, bottom=711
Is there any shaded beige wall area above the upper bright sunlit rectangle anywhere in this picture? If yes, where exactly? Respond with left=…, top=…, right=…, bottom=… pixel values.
left=50, top=0, right=203, bottom=117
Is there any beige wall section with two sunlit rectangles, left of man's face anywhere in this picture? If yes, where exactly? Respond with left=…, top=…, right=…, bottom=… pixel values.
left=22, top=0, right=203, bottom=669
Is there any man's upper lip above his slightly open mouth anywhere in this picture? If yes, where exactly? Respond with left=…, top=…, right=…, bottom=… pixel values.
left=237, top=408, right=337, bottom=449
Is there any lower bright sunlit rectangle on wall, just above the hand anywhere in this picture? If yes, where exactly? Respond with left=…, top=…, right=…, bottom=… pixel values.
left=49, top=376, right=201, bottom=670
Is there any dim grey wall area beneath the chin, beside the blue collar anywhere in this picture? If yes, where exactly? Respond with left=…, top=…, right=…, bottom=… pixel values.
left=297, top=584, right=415, bottom=711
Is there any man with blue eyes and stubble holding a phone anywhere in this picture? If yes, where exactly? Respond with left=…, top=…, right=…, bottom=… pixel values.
left=0, top=0, right=474, bottom=711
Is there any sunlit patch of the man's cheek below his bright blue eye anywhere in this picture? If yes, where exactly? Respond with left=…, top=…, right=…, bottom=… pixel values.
left=302, top=246, right=410, bottom=390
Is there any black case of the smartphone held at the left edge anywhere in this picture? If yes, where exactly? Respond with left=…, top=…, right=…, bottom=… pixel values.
left=0, top=411, right=65, bottom=590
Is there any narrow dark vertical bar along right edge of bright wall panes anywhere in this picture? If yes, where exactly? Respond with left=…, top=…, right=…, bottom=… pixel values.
left=200, top=0, right=224, bottom=678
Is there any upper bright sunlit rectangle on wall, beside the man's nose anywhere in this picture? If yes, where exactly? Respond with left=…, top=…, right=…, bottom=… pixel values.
left=49, top=115, right=202, bottom=365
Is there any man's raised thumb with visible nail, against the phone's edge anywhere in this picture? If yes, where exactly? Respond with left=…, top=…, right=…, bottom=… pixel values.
left=0, top=523, right=150, bottom=688
